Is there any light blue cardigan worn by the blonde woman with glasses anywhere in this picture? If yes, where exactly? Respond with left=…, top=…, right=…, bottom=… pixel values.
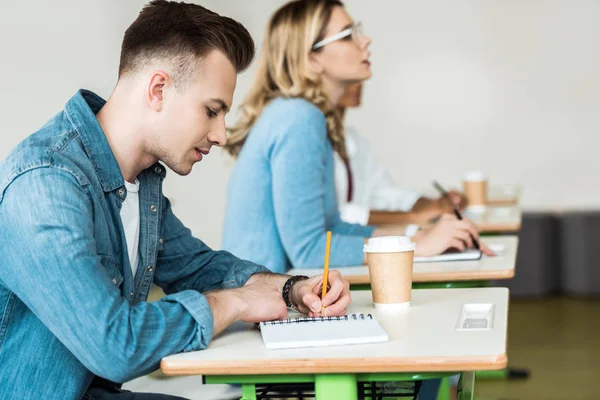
left=223, top=98, right=374, bottom=272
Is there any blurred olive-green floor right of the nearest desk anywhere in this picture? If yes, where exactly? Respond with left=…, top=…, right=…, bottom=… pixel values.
left=475, top=297, right=600, bottom=400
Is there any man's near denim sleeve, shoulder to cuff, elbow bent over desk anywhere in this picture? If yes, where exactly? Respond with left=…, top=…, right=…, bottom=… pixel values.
left=0, top=168, right=220, bottom=382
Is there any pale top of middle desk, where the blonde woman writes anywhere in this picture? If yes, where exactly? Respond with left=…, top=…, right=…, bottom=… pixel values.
left=288, top=236, right=519, bottom=284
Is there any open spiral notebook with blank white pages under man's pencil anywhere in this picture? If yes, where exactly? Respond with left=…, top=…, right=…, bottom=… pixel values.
left=258, top=314, right=388, bottom=349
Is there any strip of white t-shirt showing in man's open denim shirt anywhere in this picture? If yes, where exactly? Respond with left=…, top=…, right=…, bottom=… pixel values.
left=121, top=179, right=140, bottom=277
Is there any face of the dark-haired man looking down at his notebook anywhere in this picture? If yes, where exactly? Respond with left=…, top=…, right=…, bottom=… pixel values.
left=148, top=50, right=237, bottom=175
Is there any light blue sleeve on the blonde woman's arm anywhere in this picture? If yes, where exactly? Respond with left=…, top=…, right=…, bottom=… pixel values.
left=271, top=106, right=373, bottom=268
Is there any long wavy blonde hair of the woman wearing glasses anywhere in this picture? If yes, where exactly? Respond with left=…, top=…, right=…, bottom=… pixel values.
left=225, top=0, right=347, bottom=159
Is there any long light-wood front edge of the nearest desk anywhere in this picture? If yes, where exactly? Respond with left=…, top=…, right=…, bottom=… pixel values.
left=160, top=353, right=508, bottom=375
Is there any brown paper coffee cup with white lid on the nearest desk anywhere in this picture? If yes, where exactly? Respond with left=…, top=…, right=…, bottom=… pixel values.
left=363, top=236, right=415, bottom=311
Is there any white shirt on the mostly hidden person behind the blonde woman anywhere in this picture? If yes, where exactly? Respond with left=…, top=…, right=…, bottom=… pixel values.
left=334, top=127, right=421, bottom=225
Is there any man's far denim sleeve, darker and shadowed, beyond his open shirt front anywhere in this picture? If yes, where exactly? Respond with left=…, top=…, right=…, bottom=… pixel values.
left=154, top=197, right=269, bottom=293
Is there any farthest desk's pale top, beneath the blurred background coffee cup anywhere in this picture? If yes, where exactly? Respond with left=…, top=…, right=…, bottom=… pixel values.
left=463, top=206, right=521, bottom=233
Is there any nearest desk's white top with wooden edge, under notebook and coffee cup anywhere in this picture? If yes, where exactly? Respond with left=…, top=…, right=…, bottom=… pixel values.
left=161, top=288, right=508, bottom=375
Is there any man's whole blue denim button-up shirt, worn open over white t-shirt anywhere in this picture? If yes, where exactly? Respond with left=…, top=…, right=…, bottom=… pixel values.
left=0, top=90, right=266, bottom=400
